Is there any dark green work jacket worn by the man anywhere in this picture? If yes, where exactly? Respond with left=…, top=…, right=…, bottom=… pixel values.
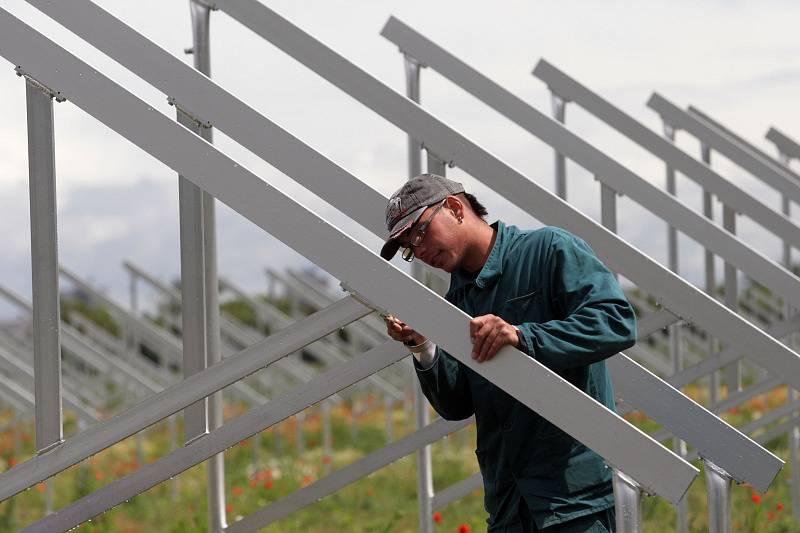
left=414, top=222, right=636, bottom=531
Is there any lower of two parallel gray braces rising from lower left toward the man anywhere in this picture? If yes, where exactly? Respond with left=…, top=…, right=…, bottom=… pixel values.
left=22, top=342, right=408, bottom=532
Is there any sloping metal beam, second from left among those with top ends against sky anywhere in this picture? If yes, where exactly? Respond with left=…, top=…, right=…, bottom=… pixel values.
left=533, top=59, right=800, bottom=248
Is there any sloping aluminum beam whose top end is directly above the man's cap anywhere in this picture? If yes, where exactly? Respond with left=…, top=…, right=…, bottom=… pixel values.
left=378, top=17, right=800, bottom=308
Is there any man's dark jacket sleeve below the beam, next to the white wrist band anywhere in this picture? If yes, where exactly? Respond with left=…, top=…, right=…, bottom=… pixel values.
left=412, top=346, right=475, bottom=420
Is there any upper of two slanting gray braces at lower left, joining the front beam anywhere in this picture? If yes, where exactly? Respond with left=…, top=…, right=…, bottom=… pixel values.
left=0, top=288, right=371, bottom=500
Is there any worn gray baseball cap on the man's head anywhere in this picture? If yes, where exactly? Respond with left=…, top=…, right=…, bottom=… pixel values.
left=381, top=174, right=464, bottom=261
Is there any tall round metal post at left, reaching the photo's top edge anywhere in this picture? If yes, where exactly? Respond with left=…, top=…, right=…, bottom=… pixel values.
left=181, top=0, right=227, bottom=532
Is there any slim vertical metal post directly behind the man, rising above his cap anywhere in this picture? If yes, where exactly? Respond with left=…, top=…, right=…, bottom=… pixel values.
left=403, top=55, right=434, bottom=533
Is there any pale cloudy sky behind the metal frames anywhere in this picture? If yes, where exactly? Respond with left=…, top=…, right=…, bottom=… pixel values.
left=0, top=0, right=800, bottom=314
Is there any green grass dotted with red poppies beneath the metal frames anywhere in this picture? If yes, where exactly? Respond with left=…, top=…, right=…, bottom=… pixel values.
left=0, top=388, right=800, bottom=533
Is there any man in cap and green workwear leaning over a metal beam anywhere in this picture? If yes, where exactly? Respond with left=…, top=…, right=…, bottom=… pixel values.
left=381, top=174, right=636, bottom=533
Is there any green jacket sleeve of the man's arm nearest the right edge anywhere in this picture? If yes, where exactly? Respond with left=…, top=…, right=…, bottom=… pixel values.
left=518, top=233, right=636, bottom=371
